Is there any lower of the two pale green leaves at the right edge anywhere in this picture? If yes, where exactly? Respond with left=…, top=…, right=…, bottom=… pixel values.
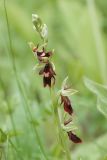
left=97, top=98, right=107, bottom=118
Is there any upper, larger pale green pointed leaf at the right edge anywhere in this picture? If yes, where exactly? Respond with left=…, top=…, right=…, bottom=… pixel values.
left=84, top=77, right=107, bottom=103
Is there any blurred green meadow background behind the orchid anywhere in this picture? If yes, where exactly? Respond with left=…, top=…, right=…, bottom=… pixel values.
left=0, top=0, right=107, bottom=160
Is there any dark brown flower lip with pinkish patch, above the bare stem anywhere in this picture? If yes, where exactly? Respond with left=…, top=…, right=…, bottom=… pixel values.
left=39, top=62, right=56, bottom=87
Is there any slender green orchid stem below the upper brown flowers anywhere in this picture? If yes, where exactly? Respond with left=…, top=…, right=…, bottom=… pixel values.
left=50, top=88, right=71, bottom=160
